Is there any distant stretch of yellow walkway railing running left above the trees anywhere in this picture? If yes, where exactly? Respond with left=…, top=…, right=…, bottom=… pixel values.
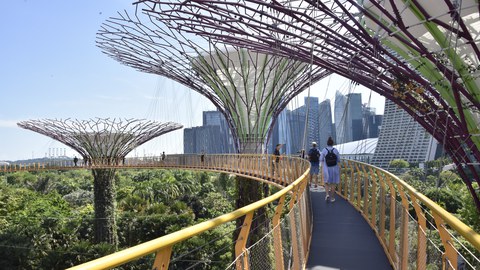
left=0, top=154, right=309, bottom=190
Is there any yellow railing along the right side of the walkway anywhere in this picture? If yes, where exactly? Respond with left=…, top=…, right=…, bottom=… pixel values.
left=338, top=160, right=480, bottom=269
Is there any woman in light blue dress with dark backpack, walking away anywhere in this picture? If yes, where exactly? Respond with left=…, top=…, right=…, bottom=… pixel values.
left=320, top=137, right=340, bottom=202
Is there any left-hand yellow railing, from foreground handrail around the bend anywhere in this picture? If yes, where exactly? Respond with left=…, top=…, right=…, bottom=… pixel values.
left=57, top=155, right=312, bottom=269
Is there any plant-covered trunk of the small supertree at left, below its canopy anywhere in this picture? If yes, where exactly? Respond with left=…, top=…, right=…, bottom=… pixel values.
left=92, top=169, right=118, bottom=246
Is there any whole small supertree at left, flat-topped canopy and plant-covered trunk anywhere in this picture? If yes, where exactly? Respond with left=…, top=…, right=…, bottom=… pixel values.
left=17, top=118, right=183, bottom=246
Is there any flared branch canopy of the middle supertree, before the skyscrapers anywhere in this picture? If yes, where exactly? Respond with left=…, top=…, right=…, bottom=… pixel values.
left=97, top=4, right=331, bottom=153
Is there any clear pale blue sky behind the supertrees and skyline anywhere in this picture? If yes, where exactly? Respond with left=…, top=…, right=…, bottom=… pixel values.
left=0, top=0, right=384, bottom=160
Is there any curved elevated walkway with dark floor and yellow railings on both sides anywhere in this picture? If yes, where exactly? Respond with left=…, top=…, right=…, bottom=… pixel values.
left=0, top=155, right=480, bottom=270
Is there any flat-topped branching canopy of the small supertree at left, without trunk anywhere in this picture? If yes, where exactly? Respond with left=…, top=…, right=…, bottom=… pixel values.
left=17, top=118, right=183, bottom=165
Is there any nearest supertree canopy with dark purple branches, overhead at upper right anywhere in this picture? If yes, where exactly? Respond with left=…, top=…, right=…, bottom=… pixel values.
left=138, top=0, right=480, bottom=211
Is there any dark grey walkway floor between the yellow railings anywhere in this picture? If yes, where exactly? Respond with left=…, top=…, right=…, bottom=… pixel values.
left=306, top=187, right=392, bottom=270
